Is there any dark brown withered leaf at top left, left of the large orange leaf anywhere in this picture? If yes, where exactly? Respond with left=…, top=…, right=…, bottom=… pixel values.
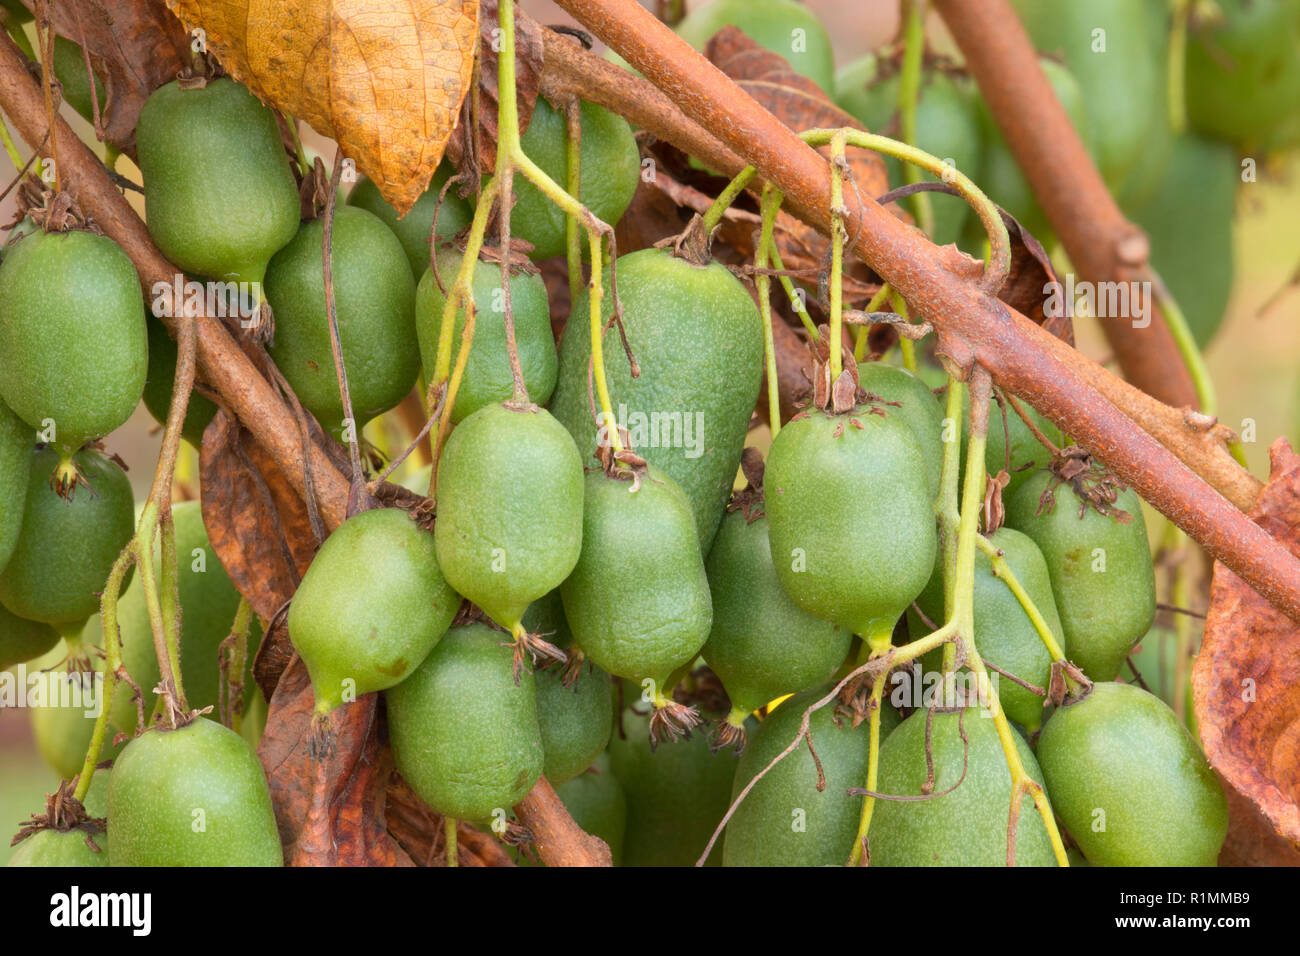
left=26, top=0, right=190, bottom=153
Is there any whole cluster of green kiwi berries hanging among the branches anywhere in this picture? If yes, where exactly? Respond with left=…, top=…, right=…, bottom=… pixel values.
left=0, top=0, right=1263, bottom=865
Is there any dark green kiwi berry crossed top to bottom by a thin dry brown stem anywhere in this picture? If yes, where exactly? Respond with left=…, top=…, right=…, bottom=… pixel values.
left=267, top=206, right=420, bottom=433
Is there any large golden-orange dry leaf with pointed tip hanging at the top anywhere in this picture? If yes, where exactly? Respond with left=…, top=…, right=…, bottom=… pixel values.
left=168, top=0, right=478, bottom=213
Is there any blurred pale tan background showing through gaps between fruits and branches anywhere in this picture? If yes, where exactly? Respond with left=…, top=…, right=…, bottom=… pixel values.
left=0, top=0, right=1300, bottom=862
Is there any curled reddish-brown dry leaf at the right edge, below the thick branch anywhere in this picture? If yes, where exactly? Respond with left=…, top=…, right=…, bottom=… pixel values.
left=1192, top=438, right=1300, bottom=847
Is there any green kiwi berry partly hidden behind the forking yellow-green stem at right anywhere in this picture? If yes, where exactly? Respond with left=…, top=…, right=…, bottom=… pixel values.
left=907, top=528, right=1070, bottom=731
